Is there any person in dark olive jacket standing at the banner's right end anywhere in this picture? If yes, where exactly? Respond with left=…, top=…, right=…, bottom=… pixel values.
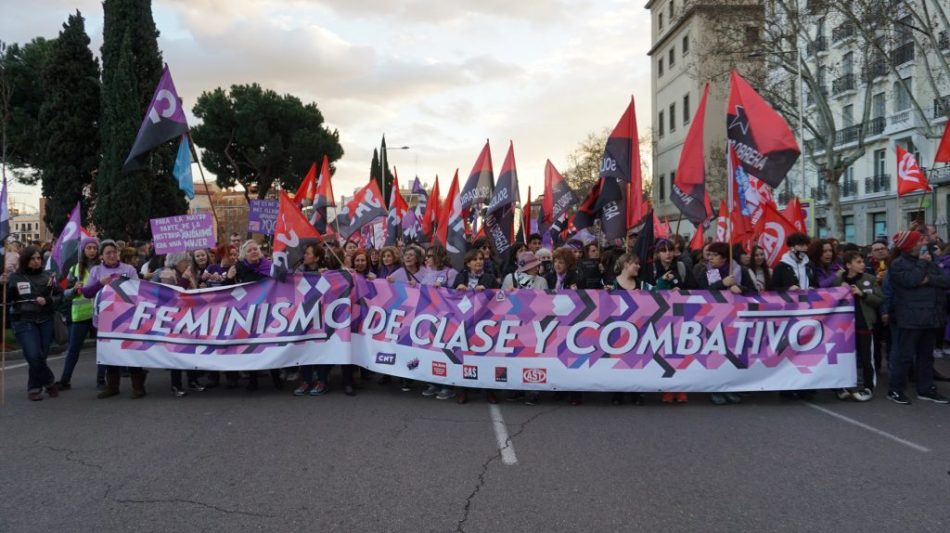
left=832, top=252, right=884, bottom=402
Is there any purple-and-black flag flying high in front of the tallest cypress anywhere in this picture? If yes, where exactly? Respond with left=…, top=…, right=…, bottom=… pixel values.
left=122, top=65, right=188, bottom=171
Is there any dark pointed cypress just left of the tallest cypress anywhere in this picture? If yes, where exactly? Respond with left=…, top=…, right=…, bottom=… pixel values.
left=37, top=11, right=99, bottom=234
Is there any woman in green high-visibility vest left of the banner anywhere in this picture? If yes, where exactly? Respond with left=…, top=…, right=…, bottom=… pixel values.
left=58, top=237, right=106, bottom=390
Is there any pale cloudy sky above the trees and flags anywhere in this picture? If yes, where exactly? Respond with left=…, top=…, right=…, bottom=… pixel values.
left=0, top=0, right=650, bottom=212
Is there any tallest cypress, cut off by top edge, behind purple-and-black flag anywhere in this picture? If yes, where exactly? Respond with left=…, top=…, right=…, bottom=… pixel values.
left=93, top=0, right=187, bottom=239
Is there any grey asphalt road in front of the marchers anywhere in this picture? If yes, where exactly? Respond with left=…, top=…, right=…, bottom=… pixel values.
left=0, top=353, right=950, bottom=532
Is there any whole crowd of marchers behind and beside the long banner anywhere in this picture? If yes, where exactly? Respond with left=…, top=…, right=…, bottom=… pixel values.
left=2, top=222, right=950, bottom=405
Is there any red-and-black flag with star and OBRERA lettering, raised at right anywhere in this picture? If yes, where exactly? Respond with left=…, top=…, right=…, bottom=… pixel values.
left=726, top=70, right=801, bottom=188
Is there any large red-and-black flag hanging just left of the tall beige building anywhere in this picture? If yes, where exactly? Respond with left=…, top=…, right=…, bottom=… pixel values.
left=574, top=97, right=645, bottom=244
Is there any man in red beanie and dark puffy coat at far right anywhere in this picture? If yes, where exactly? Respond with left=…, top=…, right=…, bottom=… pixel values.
left=887, top=231, right=950, bottom=405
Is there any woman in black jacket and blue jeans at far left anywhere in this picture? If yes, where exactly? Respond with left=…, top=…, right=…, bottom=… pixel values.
left=3, top=246, right=62, bottom=401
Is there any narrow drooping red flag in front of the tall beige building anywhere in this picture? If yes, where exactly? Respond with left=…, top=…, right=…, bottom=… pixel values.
left=670, top=83, right=712, bottom=224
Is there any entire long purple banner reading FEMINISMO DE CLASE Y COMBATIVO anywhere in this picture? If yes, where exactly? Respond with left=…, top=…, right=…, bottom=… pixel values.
left=93, top=273, right=857, bottom=392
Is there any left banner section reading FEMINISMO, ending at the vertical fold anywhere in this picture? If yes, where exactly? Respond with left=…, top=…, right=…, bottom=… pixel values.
left=96, top=274, right=352, bottom=370
